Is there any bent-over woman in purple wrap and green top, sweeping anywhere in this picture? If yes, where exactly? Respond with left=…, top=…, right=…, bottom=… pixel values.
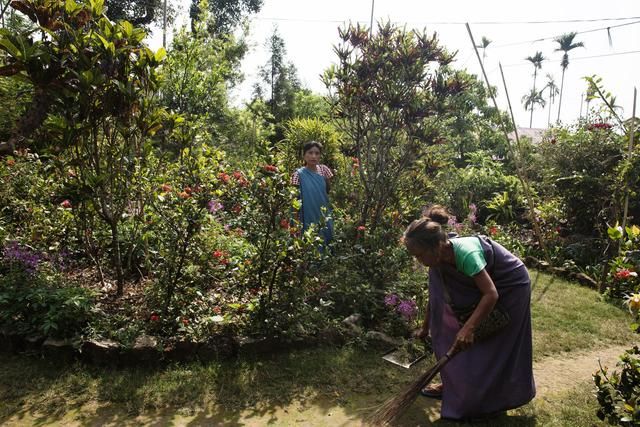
left=404, top=206, right=535, bottom=420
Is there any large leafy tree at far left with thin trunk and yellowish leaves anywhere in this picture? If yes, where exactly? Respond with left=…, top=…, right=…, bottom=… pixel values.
left=0, top=0, right=164, bottom=295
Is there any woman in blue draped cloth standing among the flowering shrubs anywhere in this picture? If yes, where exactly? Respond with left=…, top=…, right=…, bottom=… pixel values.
left=291, top=141, right=333, bottom=244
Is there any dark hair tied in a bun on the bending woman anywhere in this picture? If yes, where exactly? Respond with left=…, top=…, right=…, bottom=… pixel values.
left=402, top=205, right=449, bottom=250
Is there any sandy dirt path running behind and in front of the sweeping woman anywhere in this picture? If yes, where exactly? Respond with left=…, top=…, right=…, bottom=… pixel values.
left=6, top=346, right=628, bottom=427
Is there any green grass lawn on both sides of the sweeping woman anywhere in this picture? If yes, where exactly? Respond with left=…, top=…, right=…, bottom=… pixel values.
left=0, top=272, right=636, bottom=426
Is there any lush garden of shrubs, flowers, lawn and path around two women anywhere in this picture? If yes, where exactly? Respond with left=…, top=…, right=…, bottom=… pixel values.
left=0, top=0, right=640, bottom=426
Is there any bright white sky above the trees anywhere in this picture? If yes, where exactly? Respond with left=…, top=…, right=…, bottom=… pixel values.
left=150, top=0, right=640, bottom=127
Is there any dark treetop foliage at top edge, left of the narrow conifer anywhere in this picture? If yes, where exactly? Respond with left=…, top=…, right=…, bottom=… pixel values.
left=190, top=0, right=263, bottom=36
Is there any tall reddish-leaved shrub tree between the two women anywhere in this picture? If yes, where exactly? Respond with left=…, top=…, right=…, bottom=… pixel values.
left=323, top=23, right=464, bottom=230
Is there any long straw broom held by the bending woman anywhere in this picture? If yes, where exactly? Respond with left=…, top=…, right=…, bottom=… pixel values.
left=367, top=347, right=460, bottom=426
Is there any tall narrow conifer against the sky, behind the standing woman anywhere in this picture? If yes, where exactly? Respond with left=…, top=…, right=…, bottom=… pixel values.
left=255, top=28, right=301, bottom=142
